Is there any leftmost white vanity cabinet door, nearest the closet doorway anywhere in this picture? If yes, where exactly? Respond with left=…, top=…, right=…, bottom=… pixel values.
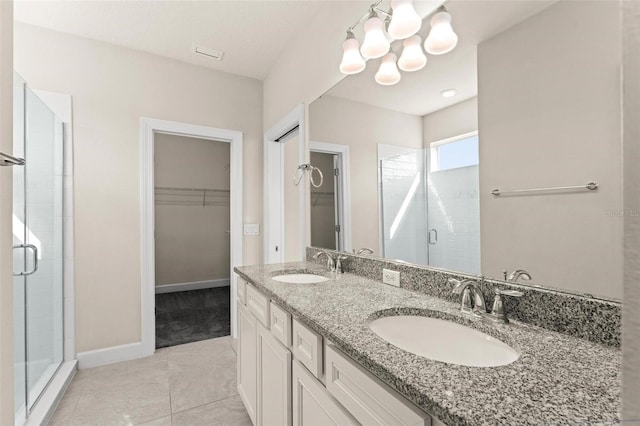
left=238, top=303, right=258, bottom=424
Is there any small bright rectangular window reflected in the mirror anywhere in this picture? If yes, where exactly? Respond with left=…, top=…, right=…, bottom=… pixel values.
left=430, top=132, right=479, bottom=172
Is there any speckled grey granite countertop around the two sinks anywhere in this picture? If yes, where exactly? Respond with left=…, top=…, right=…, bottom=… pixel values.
left=235, top=262, right=621, bottom=425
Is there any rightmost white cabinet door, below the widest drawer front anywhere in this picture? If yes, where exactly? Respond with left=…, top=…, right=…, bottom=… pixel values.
left=293, top=361, right=359, bottom=426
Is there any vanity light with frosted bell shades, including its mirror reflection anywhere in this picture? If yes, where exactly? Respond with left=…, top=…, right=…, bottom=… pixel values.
left=340, top=0, right=458, bottom=86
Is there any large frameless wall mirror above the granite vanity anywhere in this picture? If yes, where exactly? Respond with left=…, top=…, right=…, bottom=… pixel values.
left=309, top=0, right=623, bottom=300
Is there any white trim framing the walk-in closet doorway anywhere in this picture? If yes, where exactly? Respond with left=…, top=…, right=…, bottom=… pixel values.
left=140, top=117, right=244, bottom=356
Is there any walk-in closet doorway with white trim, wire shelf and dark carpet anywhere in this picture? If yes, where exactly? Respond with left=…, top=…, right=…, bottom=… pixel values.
left=141, top=119, right=242, bottom=356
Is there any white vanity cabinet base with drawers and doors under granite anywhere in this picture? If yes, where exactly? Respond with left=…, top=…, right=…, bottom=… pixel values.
left=238, top=280, right=443, bottom=426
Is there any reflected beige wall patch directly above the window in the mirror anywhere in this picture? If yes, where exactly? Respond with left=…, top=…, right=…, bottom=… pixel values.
left=422, top=98, right=478, bottom=148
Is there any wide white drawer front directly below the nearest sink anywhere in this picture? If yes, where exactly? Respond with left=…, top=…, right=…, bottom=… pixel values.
left=325, top=344, right=431, bottom=425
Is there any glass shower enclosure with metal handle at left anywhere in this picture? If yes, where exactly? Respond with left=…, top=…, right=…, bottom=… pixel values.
left=12, top=74, right=64, bottom=425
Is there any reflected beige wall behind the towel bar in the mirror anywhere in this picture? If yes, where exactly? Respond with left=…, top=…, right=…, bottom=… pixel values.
left=478, top=1, right=623, bottom=299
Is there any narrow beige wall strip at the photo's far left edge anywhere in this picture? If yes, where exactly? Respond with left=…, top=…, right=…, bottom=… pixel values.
left=0, top=1, right=14, bottom=425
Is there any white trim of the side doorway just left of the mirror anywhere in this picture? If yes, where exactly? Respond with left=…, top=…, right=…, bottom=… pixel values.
left=263, top=104, right=307, bottom=263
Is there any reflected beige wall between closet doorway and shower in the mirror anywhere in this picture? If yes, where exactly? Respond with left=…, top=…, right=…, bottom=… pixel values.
left=309, top=96, right=422, bottom=255
